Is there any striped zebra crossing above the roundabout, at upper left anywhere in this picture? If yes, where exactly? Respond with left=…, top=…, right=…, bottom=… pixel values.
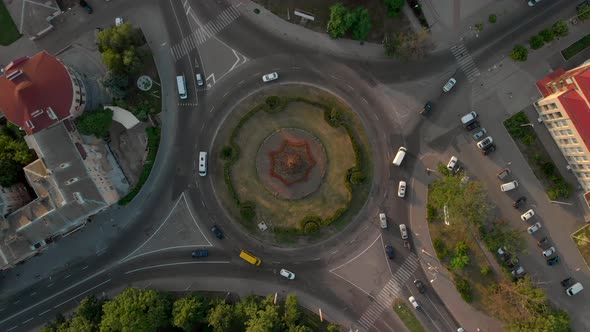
left=171, top=5, right=240, bottom=61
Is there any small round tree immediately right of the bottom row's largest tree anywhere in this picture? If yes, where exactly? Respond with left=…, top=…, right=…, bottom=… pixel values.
left=172, top=295, right=209, bottom=332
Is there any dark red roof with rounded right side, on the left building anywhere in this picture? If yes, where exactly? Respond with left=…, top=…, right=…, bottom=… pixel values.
left=0, top=51, right=74, bottom=134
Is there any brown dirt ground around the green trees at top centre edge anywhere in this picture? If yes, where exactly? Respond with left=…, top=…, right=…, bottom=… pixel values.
left=254, top=0, right=411, bottom=43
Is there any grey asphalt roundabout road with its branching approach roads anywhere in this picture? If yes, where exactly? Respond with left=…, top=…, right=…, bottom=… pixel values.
left=0, top=1, right=588, bottom=331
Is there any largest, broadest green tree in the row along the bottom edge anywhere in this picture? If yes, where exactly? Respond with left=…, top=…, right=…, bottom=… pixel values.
left=100, top=288, right=171, bottom=332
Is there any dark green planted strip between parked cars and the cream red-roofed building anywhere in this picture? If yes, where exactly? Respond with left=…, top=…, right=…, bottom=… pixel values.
left=504, top=111, right=572, bottom=200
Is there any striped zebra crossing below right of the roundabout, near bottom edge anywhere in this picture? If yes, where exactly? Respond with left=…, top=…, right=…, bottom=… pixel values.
left=358, top=253, right=419, bottom=330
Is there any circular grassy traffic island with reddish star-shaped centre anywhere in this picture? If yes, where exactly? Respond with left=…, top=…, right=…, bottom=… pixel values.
left=213, top=86, right=372, bottom=245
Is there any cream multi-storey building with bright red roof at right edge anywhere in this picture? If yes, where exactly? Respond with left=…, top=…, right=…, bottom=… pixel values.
left=534, top=61, right=590, bottom=191
